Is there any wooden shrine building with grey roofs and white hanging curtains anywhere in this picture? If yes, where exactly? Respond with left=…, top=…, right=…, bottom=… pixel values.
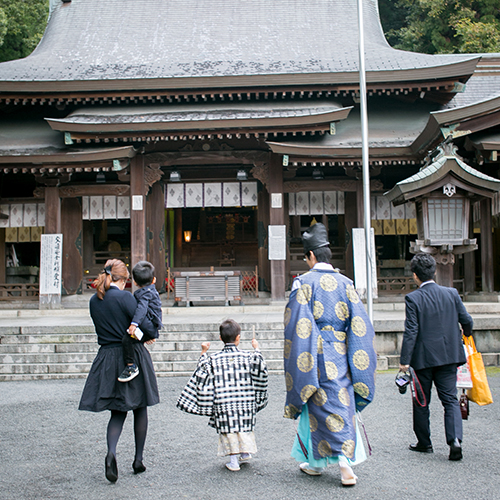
left=0, top=0, right=500, bottom=300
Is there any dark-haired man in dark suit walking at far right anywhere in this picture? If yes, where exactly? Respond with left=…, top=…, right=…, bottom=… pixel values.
left=399, top=253, right=472, bottom=460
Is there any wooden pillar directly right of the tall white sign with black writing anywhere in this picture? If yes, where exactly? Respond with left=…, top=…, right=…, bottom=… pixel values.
left=61, top=198, right=83, bottom=295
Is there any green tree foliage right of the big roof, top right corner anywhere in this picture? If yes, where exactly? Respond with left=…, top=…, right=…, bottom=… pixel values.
left=379, top=0, right=500, bottom=54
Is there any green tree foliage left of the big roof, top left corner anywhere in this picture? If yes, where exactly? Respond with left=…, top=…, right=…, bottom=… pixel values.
left=0, top=0, right=49, bottom=61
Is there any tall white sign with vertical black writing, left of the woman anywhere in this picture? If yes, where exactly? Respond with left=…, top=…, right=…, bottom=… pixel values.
left=40, top=234, right=63, bottom=295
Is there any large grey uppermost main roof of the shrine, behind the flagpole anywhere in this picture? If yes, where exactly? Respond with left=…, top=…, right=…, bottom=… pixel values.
left=0, top=0, right=477, bottom=90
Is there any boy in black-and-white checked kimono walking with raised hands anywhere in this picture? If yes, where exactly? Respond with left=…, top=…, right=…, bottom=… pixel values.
left=177, top=319, right=268, bottom=471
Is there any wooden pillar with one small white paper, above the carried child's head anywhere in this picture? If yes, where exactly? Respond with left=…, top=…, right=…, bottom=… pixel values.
left=130, top=156, right=146, bottom=274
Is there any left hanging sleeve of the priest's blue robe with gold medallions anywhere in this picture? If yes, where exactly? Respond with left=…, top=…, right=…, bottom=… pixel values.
left=283, top=288, right=319, bottom=419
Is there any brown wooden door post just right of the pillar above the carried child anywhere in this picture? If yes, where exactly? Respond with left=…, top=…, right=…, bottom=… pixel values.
left=146, top=182, right=166, bottom=293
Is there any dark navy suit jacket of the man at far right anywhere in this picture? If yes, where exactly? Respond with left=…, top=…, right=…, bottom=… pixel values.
left=400, top=282, right=472, bottom=370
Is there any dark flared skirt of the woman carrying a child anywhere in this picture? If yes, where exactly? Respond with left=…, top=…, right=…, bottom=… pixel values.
left=78, top=342, right=160, bottom=412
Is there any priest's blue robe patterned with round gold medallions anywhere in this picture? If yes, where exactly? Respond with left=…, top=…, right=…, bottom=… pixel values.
left=284, top=269, right=377, bottom=460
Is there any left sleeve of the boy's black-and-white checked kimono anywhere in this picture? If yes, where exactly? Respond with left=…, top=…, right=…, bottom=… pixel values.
left=177, top=354, right=214, bottom=417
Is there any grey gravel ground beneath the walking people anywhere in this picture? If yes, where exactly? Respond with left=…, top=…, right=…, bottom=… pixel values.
left=0, top=372, right=500, bottom=500
